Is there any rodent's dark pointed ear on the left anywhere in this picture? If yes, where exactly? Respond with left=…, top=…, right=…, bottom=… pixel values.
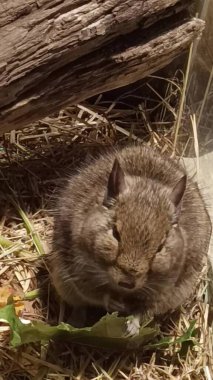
left=105, top=158, right=126, bottom=201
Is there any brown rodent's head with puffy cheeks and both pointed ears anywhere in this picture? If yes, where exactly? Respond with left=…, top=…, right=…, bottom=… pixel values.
left=81, top=159, right=186, bottom=294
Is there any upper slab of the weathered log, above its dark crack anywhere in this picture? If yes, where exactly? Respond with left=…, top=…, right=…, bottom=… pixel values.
left=0, top=0, right=191, bottom=104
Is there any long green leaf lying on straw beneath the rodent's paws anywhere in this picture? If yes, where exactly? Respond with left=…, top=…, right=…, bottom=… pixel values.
left=0, top=304, right=159, bottom=350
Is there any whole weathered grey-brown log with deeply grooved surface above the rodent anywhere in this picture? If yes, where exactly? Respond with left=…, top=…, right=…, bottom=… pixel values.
left=0, top=0, right=204, bottom=133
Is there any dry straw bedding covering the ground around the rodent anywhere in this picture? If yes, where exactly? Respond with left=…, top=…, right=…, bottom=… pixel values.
left=0, top=73, right=212, bottom=380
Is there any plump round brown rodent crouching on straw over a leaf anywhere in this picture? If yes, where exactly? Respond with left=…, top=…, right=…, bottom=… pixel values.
left=50, top=146, right=211, bottom=330
